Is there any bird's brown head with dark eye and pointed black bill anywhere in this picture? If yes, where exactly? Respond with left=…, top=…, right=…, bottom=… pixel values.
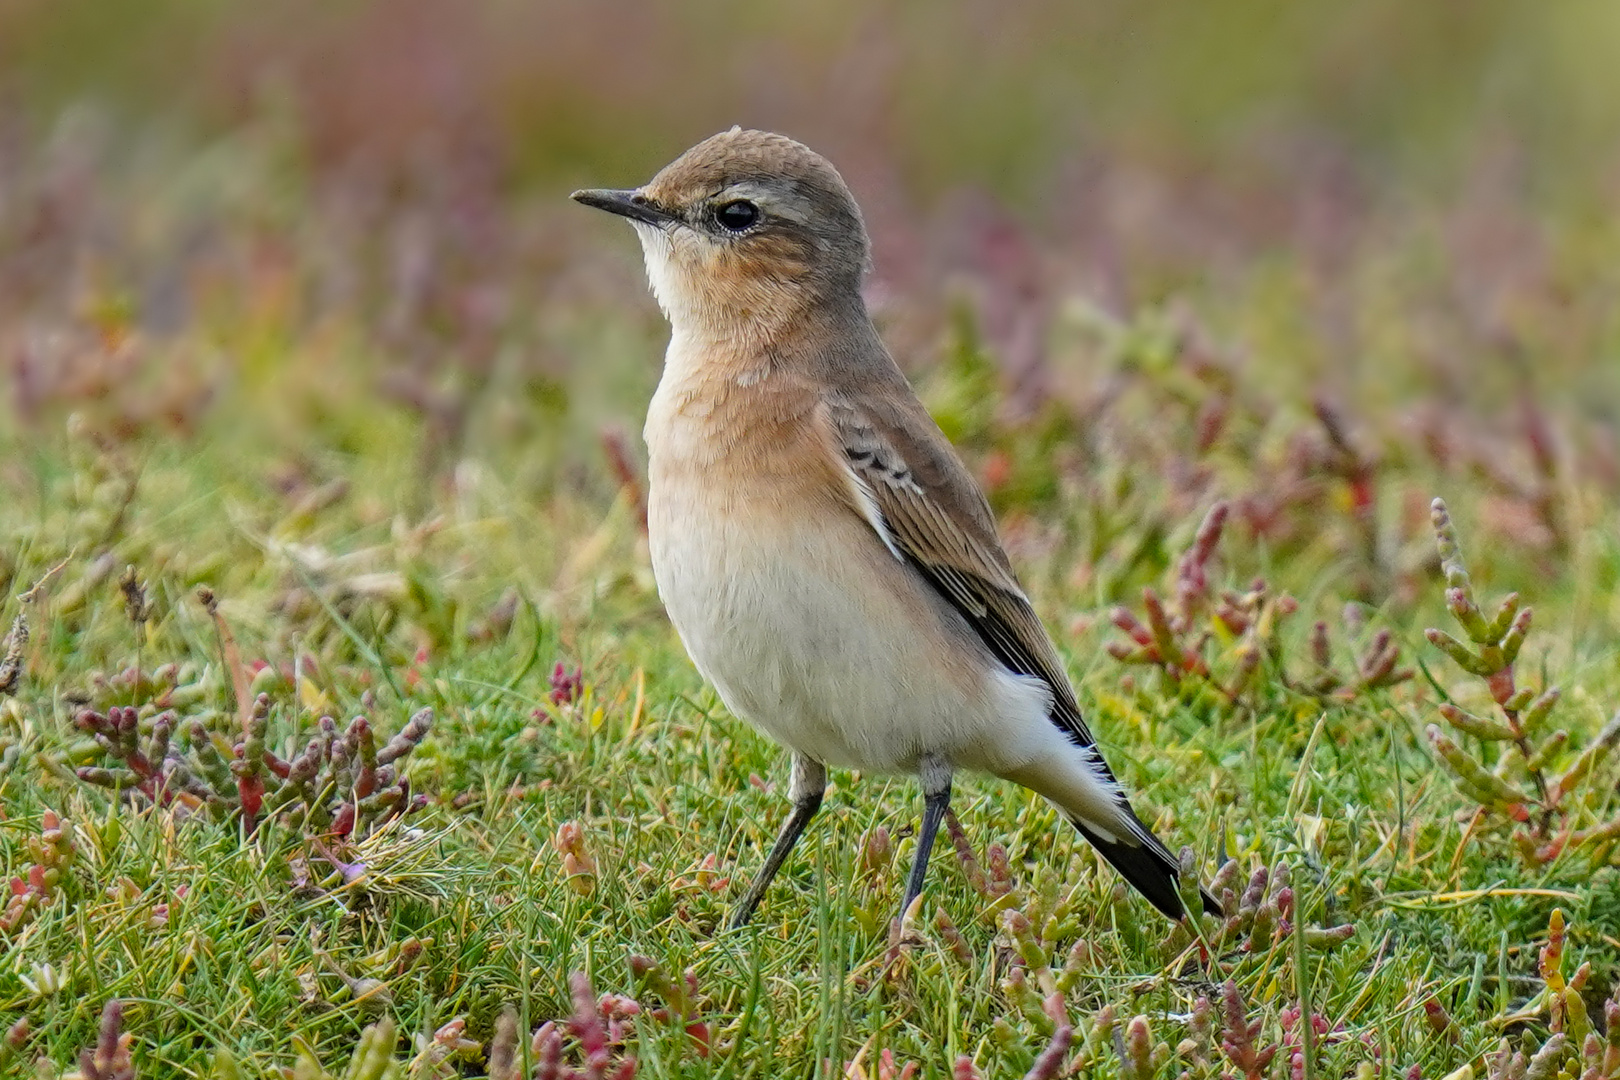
left=573, top=128, right=868, bottom=330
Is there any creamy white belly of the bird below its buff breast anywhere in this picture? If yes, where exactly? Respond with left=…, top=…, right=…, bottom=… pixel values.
left=650, top=484, right=1061, bottom=772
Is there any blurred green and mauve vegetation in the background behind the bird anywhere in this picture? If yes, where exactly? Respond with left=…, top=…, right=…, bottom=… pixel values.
left=0, top=0, right=1620, bottom=625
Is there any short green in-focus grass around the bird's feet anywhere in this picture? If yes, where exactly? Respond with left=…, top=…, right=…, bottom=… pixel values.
left=12, top=401, right=1620, bottom=1077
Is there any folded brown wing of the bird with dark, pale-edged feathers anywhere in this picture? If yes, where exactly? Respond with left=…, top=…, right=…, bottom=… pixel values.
left=821, top=392, right=1106, bottom=751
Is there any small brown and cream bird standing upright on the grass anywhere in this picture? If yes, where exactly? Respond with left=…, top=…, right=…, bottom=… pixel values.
left=573, top=128, right=1220, bottom=926
